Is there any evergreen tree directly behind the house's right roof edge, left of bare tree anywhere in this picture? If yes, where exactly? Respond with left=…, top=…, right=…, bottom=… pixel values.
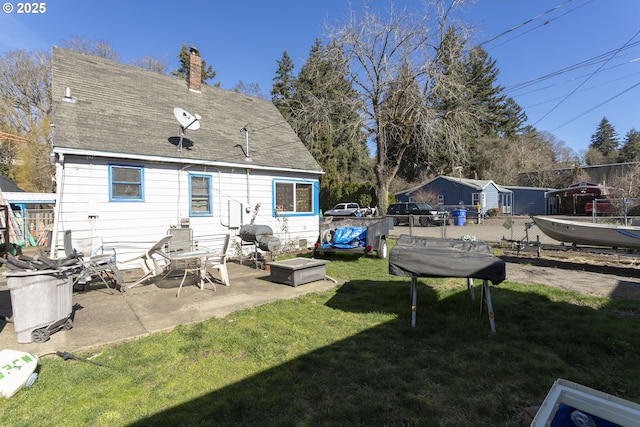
left=286, top=39, right=371, bottom=208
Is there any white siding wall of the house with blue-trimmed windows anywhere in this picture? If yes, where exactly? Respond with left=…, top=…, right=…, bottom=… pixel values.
left=54, top=156, right=318, bottom=260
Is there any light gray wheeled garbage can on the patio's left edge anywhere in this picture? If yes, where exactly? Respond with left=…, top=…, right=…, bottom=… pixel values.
left=5, top=270, right=73, bottom=344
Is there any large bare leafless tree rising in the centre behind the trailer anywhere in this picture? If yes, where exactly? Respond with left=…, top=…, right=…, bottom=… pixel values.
left=330, top=0, right=468, bottom=209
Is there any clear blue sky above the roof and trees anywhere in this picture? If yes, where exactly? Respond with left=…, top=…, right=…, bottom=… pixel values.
left=0, top=0, right=640, bottom=152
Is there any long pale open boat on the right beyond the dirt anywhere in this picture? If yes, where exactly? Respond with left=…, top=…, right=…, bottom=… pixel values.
left=531, top=216, right=640, bottom=249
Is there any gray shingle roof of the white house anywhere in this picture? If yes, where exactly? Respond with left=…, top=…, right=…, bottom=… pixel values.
left=52, top=46, right=321, bottom=173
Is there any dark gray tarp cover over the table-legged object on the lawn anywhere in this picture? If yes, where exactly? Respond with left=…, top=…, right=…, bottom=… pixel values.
left=389, top=235, right=506, bottom=285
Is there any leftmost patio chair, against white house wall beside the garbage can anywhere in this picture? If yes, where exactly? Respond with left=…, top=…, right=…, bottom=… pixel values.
left=63, top=230, right=124, bottom=293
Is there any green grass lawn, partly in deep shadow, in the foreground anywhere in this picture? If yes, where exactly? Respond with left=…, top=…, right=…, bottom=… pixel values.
left=0, top=249, right=640, bottom=426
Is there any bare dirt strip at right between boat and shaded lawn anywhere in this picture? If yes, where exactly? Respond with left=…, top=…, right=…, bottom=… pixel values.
left=501, top=246, right=640, bottom=300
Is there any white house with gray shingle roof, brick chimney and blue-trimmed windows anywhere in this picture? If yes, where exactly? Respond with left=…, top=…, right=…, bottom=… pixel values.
left=51, top=47, right=322, bottom=260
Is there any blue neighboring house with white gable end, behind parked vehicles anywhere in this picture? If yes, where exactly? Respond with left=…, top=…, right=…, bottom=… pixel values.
left=394, top=176, right=513, bottom=214
